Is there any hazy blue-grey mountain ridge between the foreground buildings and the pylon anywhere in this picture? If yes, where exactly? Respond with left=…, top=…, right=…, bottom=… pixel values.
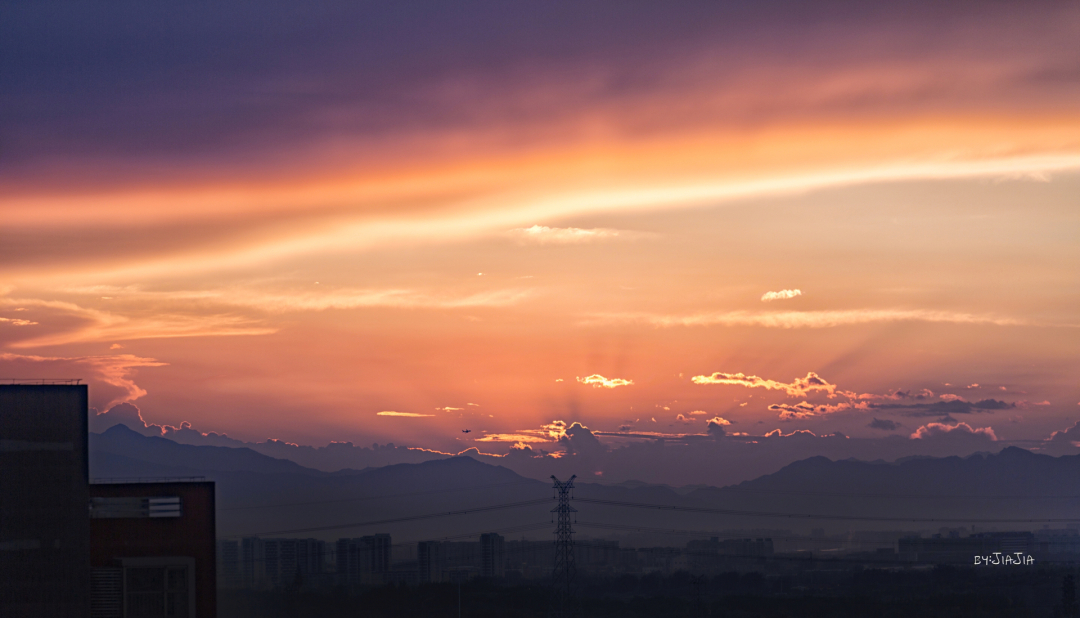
left=90, top=425, right=551, bottom=539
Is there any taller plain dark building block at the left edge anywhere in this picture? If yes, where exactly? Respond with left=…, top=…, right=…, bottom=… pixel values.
left=0, top=380, right=90, bottom=618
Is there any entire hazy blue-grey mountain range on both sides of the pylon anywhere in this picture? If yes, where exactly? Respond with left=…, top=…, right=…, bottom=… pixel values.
left=91, top=426, right=1080, bottom=545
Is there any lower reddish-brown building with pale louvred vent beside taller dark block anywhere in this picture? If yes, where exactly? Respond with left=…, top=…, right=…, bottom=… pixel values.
left=90, top=482, right=217, bottom=618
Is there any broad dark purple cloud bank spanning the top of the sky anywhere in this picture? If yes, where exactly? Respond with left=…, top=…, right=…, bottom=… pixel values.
left=0, top=0, right=1076, bottom=185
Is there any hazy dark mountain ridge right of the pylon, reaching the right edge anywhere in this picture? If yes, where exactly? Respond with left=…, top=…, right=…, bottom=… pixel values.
left=687, top=447, right=1080, bottom=530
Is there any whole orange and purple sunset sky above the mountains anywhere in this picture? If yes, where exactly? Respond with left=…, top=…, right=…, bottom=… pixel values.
left=0, top=1, right=1080, bottom=482
